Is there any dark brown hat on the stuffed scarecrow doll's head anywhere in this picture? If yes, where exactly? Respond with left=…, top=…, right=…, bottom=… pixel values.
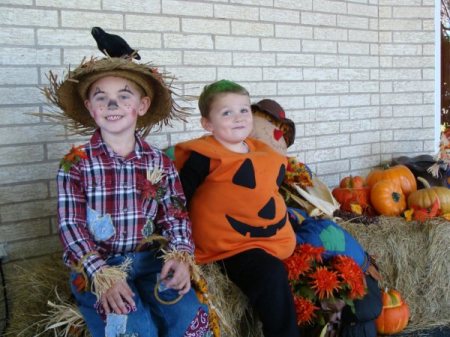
left=252, top=99, right=295, bottom=147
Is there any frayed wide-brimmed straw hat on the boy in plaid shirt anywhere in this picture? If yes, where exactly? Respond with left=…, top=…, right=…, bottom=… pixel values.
left=43, top=57, right=186, bottom=136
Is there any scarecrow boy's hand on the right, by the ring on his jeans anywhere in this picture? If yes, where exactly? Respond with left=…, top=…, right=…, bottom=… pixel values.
left=161, top=259, right=191, bottom=295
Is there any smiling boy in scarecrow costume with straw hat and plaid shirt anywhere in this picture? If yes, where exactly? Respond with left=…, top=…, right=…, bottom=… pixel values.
left=44, top=57, right=210, bottom=337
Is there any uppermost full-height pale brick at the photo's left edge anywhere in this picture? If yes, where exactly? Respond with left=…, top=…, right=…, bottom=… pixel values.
left=0, top=7, right=58, bottom=26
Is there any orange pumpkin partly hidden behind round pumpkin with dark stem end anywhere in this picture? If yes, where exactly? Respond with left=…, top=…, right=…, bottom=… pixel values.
left=366, top=165, right=417, bottom=197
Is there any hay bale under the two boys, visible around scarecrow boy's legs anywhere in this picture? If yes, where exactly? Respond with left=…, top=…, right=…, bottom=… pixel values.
left=5, top=254, right=263, bottom=337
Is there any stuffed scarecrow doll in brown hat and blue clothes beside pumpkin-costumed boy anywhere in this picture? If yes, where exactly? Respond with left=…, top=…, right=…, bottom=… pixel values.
left=251, top=99, right=382, bottom=337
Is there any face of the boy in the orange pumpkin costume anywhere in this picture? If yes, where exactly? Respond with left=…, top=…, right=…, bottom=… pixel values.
left=201, top=93, right=253, bottom=148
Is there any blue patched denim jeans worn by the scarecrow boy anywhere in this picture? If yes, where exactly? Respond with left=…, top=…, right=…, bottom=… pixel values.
left=70, top=251, right=207, bottom=337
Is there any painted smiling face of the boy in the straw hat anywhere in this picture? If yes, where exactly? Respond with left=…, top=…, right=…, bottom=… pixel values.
left=84, top=76, right=150, bottom=135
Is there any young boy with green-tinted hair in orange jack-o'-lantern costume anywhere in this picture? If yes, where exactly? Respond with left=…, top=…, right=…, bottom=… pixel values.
left=175, top=80, right=299, bottom=337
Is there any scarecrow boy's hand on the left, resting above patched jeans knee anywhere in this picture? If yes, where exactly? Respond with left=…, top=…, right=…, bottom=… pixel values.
left=100, top=281, right=136, bottom=315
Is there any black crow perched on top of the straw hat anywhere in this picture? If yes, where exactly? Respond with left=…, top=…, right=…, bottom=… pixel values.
left=91, top=27, right=141, bottom=60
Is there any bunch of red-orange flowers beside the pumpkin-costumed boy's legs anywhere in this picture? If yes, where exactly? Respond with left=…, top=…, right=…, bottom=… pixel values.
left=284, top=244, right=366, bottom=336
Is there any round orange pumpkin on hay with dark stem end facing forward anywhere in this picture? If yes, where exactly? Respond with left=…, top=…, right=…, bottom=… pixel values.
left=370, top=180, right=406, bottom=216
